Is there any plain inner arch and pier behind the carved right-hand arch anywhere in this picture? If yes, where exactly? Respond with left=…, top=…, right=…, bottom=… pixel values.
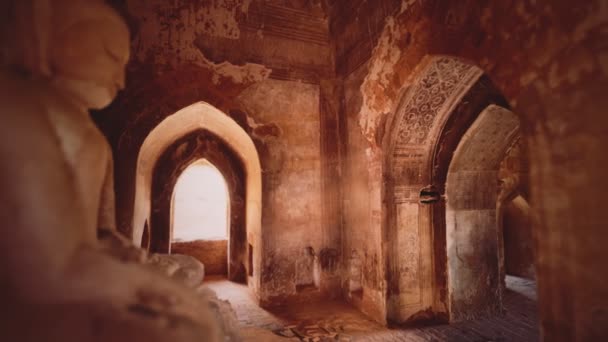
left=446, top=105, right=519, bottom=320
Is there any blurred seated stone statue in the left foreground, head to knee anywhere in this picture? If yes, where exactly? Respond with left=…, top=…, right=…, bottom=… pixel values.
left=0, top=0, right=234, bottom=341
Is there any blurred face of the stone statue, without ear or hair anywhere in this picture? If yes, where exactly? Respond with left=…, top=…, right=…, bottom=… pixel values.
left=49, top=0, right=129, bottom=109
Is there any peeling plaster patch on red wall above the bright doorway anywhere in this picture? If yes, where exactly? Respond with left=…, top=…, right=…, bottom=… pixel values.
left=128, top=0, right=272, bottom=85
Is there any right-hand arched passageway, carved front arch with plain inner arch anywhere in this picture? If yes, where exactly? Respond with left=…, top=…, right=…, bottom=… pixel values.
left=383, top=56, right=536, bottom=323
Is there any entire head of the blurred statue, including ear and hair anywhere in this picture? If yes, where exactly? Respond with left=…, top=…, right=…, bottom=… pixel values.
left=0, top=0, right=129, bottom=109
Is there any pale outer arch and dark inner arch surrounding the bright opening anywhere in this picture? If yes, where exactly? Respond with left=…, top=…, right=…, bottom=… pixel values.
left=132, top=102, right=262, bottom=290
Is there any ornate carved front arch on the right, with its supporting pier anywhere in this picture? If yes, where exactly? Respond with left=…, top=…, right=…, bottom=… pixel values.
left=383, top=56, right=506, bottom=323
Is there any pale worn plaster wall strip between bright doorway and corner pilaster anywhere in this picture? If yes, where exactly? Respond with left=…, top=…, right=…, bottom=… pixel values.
left=237, top=80, right=325, bottom=303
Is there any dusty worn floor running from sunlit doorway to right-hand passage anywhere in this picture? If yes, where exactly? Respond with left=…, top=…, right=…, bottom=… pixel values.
left=205, top=276, right=539, bottom=342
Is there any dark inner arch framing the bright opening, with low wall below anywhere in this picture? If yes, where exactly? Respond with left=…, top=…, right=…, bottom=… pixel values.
left=150, top=129, right=251, bottom=282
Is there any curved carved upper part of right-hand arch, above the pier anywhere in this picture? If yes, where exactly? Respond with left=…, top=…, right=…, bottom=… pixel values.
left=383, top=56, right=483, bottom=201
